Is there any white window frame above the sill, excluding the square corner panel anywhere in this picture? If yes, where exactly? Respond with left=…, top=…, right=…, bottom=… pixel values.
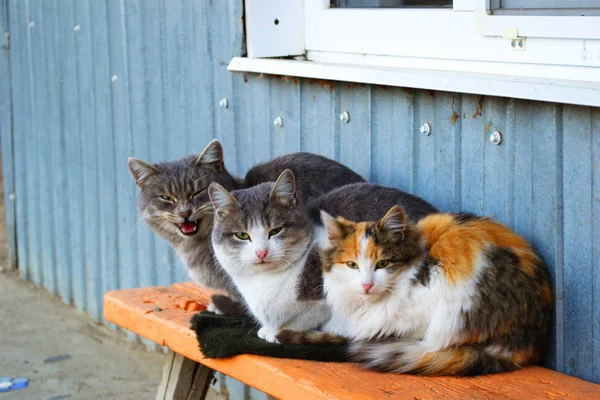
left=305, top=0, right=600, bottom=66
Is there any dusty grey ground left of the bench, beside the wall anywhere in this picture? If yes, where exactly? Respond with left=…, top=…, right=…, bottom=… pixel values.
left=0, top=158, right=224, bottom=400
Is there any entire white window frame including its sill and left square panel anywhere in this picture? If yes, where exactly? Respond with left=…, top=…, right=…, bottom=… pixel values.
left=229, top=0, right=600, bottom=106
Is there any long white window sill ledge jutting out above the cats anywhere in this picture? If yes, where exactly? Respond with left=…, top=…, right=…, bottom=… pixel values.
left=228, top=57, right=600, bottom=107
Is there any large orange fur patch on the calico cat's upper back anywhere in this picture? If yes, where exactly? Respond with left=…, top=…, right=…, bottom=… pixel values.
left=418, top=214, right=539, bottom=284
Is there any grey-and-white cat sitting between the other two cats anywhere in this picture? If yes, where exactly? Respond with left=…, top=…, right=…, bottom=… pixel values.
left=209, top=170, right=437, bottom=341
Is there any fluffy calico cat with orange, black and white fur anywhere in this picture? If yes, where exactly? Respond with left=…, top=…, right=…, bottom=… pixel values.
left=313, top=206, right=553, bottom=375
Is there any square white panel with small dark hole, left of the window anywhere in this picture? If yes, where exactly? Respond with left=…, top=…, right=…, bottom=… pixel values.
left=244, top=0, right=304, bottom=57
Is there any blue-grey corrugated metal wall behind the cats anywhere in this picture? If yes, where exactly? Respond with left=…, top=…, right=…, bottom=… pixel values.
left=0, top=0, right=600, bottom=388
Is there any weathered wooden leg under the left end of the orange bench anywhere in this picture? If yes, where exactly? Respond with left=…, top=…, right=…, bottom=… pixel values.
left=156, top=350, right=215, bottom=400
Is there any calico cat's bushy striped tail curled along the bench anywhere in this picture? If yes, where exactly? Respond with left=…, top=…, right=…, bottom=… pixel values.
left=350, top=340, right=537, bottom=376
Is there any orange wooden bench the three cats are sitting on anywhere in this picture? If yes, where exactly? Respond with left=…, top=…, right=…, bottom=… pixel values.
left=104, top=283, right=600, bottom=400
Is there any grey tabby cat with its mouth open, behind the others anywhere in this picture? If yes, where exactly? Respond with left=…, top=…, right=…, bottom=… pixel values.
left=128, top=140, right=364, bottom=297
